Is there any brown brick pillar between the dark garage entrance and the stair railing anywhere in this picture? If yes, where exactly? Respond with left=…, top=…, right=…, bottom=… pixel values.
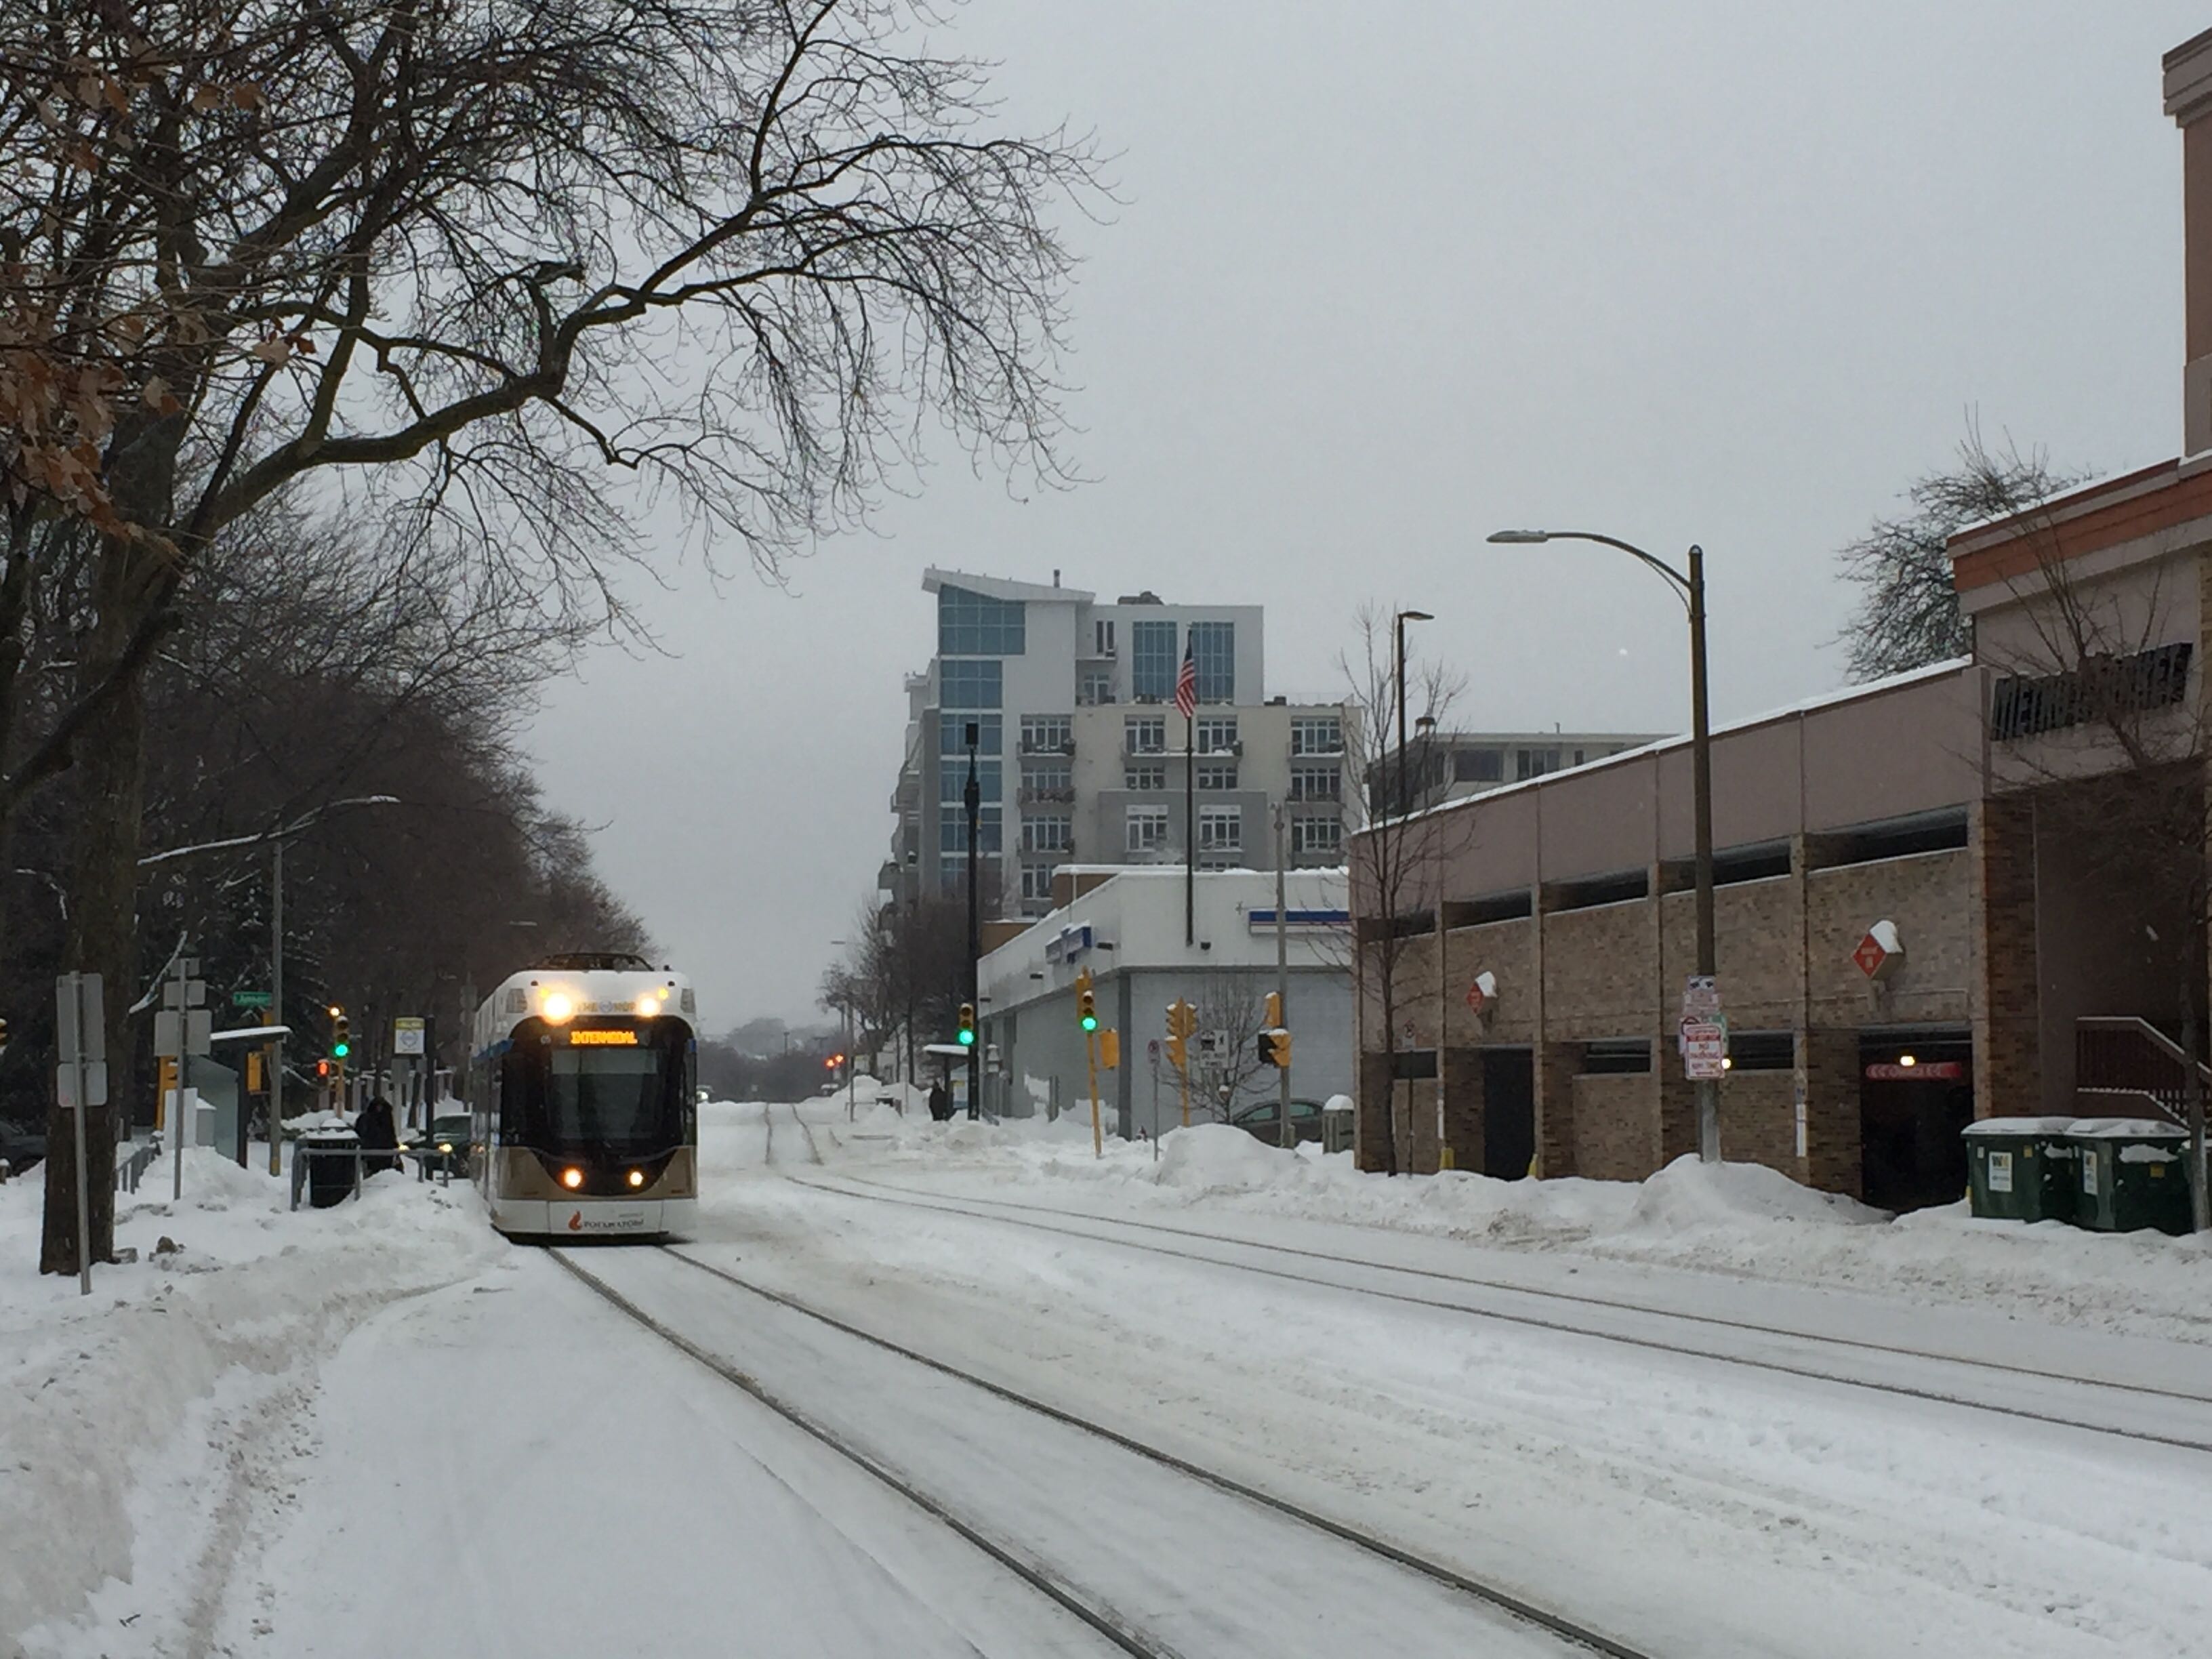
left=1967, top=794, right=2042, bottom=1117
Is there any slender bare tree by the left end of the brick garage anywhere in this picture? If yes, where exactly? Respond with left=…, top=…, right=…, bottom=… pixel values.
left=1338, top=604, right=1469, bottom=1174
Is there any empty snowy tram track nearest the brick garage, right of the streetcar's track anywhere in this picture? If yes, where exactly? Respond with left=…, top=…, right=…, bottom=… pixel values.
left=781, top=1168, right=2212, bottom=1453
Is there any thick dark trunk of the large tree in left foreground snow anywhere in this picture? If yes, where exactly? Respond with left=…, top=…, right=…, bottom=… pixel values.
left=37, top=544, right=155, bottom=1274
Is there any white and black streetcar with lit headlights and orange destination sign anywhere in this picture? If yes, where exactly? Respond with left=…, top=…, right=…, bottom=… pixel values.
left=469, top=951, right=699, bottom=1239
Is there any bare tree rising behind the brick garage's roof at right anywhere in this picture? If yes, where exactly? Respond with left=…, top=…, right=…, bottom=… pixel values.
left=1836, top=431, right=2079, bottom=681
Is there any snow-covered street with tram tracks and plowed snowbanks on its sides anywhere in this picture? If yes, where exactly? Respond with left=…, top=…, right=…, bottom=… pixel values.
left=0, top=1099, right=2212, bottom=1659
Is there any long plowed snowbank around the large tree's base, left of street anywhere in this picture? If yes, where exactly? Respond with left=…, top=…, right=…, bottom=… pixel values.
left=0, top=1148, right=506, bottom=1652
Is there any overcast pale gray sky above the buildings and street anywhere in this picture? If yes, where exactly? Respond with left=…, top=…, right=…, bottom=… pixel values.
left=533, top=0, right=2207, bottom=1031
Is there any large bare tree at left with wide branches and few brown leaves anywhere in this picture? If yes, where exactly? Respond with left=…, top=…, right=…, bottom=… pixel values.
left=0, top=0, right=1097, bottom=1265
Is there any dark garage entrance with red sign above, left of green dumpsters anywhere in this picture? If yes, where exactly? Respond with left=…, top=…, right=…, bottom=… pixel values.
left=1858, top=1026, right=1973, bottom=1210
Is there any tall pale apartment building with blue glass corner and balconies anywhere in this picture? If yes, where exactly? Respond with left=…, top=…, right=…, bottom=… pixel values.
left=880, top=569, right=1356, bottom=916
